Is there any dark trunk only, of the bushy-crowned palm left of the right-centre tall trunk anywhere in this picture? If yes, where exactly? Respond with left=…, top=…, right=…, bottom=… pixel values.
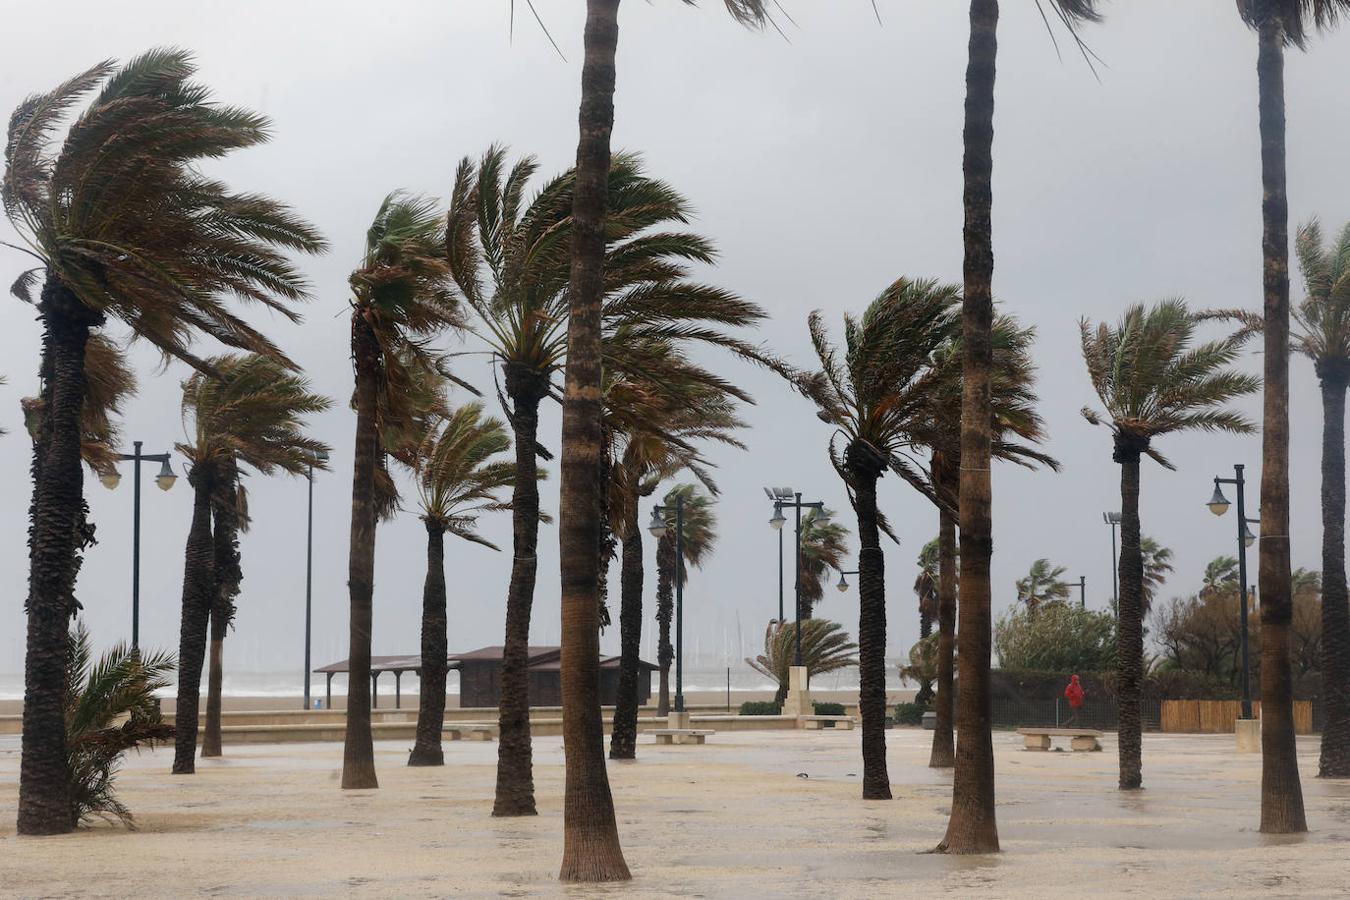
left=849, top=461, right=891, bottom=800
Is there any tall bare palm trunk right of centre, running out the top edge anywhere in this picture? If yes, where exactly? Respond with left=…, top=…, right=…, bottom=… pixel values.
left=937, top=0, right=999, bottom=853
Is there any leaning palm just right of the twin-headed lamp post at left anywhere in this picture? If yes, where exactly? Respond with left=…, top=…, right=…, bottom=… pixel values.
left=173, top=354, right=331, bottom=775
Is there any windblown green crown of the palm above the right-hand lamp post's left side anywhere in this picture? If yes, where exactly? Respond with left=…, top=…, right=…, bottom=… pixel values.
left=1080, top=300, right=1260, bottom=468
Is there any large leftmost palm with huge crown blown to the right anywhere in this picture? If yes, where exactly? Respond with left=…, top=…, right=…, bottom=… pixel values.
left=0, top=50, right=324, bottom=834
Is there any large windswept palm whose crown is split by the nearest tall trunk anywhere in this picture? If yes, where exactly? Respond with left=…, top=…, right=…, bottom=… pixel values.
left=447, top=146, right=778, bottom=816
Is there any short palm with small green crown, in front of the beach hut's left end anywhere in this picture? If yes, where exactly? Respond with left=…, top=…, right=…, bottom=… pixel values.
left=408, top=403, right=516, bottom=765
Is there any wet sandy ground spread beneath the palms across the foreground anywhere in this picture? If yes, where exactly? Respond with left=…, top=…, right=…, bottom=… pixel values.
left=0, top=729, right=1350, bottom=897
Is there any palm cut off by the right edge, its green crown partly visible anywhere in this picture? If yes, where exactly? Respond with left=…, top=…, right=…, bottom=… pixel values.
left=1293, top=219, right=1350, bottom=779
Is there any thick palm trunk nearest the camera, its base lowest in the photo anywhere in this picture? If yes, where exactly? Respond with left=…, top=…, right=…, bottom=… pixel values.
left=559, top=0, right=630, bottom=882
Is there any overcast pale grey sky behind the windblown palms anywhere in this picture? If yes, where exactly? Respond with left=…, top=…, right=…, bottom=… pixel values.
left=0, top=0, right=1350, bottom=685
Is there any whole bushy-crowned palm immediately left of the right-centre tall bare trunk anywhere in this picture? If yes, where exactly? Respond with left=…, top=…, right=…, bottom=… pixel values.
left=799, top=278, right=959, bottom=800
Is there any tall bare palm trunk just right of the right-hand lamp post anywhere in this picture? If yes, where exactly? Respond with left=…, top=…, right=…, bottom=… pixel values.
left=1257, top=10, right=1308, bottom=834
